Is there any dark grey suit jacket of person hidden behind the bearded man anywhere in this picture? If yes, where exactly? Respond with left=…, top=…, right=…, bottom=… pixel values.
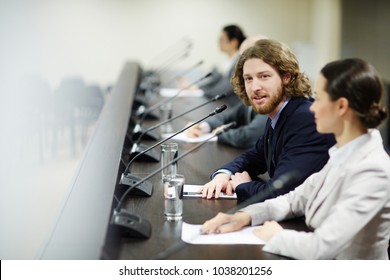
left=207, top=102, right=268, bottom=149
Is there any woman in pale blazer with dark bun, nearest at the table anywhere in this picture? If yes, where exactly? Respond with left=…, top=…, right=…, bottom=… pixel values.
left=202, top=59, right=390, bottom=259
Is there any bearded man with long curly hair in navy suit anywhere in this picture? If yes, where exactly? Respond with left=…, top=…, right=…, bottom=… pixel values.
left=201, top=39, right=335, bottom=200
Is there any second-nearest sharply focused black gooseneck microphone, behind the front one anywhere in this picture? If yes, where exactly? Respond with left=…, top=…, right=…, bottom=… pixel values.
left=119, top=104, right=227, bottom=196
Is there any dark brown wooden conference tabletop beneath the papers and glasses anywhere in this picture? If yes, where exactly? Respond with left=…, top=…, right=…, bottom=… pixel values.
left=102, top=83, right=307, bottom=260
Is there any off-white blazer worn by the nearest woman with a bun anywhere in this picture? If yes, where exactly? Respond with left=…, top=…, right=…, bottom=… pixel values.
left=241, top=129, right=390, bottom=259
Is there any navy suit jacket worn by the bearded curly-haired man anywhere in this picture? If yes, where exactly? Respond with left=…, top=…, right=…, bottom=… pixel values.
left=216, top=98, right=335, bottom=201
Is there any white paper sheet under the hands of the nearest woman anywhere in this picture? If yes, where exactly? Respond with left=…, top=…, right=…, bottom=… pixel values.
left=181, top=222, right=265, bottom=245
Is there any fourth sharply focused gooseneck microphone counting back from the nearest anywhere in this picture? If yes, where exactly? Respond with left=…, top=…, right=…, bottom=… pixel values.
left=132, top=73, right=212, bottom=140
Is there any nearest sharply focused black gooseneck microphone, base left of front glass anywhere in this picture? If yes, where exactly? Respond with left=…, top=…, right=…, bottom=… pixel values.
left=110, top=122, right=236, bottom=238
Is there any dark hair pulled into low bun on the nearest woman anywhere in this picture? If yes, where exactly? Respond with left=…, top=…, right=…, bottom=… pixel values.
left=321, top=58, right=387, bottom=128
